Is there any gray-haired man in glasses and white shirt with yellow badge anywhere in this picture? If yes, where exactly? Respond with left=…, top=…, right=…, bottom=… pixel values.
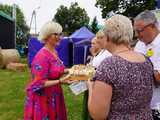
left=134, top=10, right=160, bottom=120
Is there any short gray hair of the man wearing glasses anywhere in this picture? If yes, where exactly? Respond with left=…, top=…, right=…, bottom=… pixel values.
left=134, top=10, right=157, bottom=25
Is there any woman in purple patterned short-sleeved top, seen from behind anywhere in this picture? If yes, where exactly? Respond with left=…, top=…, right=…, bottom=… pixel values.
left=88, top=15, right=154, bottom=120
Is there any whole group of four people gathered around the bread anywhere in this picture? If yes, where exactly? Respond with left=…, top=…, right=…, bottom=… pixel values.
left=24, top=10, right=160, bottom=120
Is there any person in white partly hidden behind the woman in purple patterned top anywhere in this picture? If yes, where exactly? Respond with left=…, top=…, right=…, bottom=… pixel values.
left=91, top=30, right=112, bottom=68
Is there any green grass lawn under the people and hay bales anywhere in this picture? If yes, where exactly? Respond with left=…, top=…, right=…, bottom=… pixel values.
left=0, top=59, right=83, bottom=120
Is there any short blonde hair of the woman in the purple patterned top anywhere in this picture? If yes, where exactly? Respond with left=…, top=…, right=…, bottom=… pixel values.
left=104, top=14, right=133, bottom=44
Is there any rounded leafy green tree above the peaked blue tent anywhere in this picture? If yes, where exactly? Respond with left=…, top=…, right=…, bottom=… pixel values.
left=53, top=2, right=89, bottom=35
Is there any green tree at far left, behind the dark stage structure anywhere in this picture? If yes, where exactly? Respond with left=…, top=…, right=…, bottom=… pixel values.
left=0, top=4, right=29, bottom=45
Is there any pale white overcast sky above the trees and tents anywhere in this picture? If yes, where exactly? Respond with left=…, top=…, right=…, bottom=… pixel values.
left=0, top=0, right=104, bottom=32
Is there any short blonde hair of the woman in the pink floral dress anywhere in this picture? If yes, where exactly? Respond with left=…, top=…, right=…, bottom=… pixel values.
left=39, top=21, right=62, bottom=42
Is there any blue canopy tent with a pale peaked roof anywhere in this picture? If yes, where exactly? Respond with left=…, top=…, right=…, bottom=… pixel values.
left=69, top=27, right=95, bottom=64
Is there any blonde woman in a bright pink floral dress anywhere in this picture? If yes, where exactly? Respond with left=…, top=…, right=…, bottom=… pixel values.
left=24, top=22, right=67, bottom=120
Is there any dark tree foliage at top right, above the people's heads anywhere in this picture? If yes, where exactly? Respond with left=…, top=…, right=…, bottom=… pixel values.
left=96, top=0, right=156, bottom=18
